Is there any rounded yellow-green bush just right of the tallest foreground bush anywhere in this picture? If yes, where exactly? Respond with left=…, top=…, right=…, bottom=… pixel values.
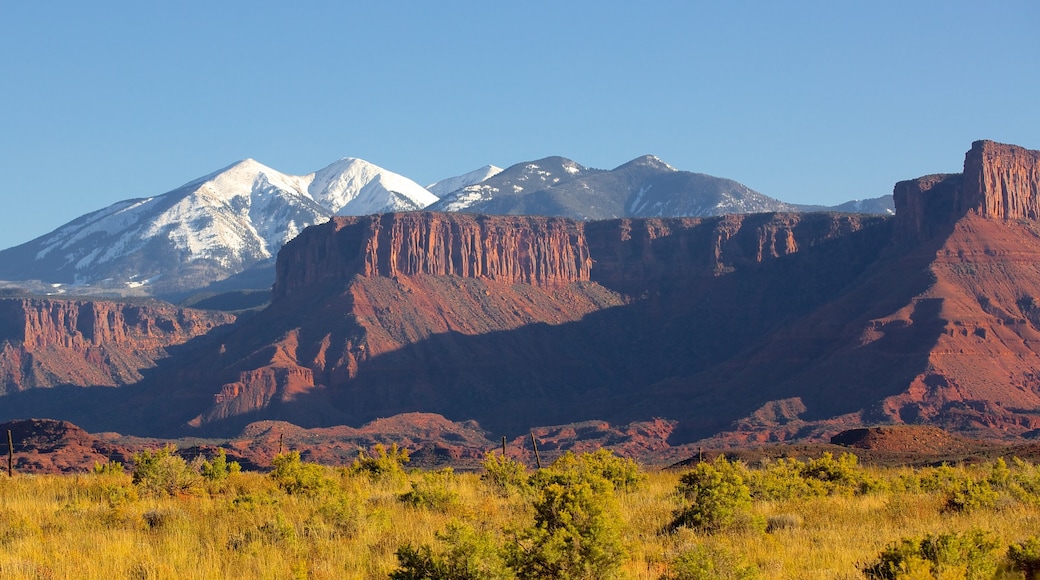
left=671, top=456, right=765, bottom=533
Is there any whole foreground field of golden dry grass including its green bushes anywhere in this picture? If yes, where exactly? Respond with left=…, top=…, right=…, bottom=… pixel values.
left=0, top=448, right=1040, bottom=579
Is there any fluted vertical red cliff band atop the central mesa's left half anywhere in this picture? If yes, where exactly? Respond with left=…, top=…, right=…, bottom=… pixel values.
left=275, top=213, right=592, bottom=299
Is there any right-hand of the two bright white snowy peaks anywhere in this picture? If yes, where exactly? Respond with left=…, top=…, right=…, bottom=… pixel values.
left=308, top=157, right=438, bottom=215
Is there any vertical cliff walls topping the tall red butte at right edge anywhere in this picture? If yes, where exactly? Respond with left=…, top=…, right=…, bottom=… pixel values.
left=892, top=140, right=1040, bottom=241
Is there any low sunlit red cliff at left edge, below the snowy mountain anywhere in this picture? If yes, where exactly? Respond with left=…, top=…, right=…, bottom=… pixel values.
left=0, top=298, right=234, bottom=394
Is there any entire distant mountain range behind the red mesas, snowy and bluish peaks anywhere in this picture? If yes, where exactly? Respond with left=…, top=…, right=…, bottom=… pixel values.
left=0, top=156, right=891, bottom=298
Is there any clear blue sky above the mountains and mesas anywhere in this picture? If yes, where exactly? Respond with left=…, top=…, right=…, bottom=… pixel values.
left=0, top=0, right=1040, bottom=252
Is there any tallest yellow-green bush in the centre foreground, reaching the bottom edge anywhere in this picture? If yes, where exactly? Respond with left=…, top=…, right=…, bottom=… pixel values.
left=508, top=473, right=625, bottom=579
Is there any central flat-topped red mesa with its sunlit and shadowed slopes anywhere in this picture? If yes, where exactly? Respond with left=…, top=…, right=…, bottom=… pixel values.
left=166, top=213, right=890, bottom=436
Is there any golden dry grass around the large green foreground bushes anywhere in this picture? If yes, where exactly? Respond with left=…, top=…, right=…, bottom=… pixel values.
left=0, top=455, right=1040, bottom=579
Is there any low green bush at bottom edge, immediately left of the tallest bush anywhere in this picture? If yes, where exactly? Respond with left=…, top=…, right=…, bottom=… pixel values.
left=390, top=523, right=516, bottom=580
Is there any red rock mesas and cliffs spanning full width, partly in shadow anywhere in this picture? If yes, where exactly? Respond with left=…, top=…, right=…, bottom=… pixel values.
left=0, top=141, right=1040, bottom=455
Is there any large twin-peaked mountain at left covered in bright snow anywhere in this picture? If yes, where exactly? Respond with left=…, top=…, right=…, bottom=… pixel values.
left=0, top=158, right=437, bottom=293
